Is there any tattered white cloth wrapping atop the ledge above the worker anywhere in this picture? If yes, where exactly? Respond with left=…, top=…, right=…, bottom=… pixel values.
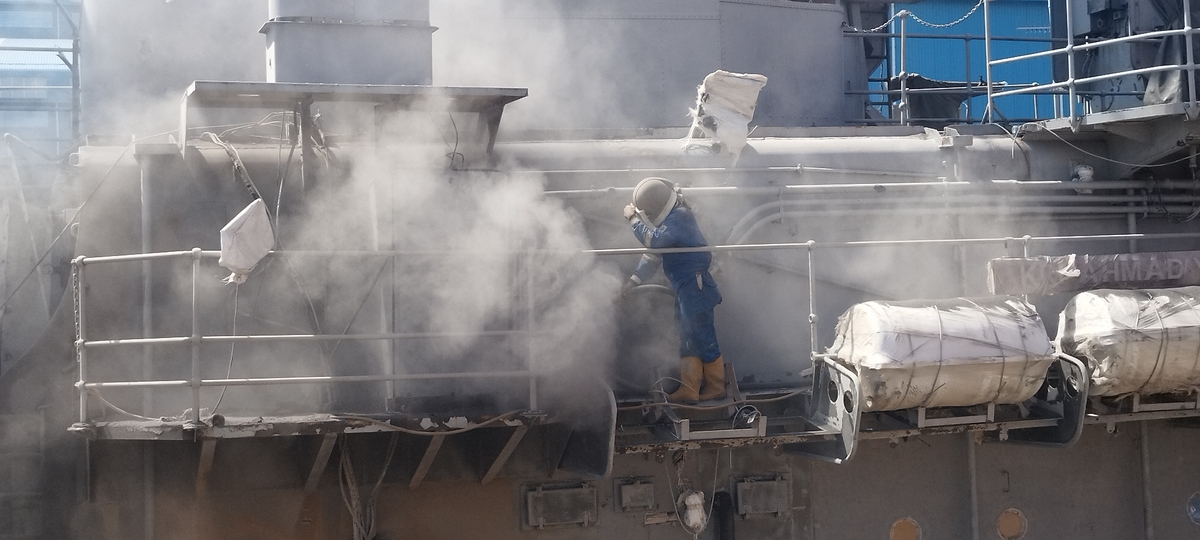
left=686, top=70, right=767, bottom=155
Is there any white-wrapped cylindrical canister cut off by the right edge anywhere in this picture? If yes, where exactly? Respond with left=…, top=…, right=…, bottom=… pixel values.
left=1058, top=287, right=1200, bottom=396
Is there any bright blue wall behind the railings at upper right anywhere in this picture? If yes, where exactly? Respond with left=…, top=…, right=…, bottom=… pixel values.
left=890, top=0, right=1054, bottom=121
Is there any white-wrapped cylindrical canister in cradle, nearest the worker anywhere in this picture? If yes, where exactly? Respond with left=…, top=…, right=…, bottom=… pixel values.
left=829, top=296, right=1054, bottom=410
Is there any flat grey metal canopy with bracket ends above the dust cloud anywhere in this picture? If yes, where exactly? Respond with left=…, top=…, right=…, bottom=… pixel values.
left=179, top=80, right=529, bottom=154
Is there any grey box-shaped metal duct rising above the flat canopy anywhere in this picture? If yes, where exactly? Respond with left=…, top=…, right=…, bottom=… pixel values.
left=259, top=0, right=437, bottom=84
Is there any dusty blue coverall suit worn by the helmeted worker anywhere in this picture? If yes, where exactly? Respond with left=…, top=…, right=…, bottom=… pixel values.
left=630, top=204, right=721, bottom=364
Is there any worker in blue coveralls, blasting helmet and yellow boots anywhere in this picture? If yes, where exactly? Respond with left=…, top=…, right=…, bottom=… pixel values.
left=622, top=178, right=725, bottom=402
